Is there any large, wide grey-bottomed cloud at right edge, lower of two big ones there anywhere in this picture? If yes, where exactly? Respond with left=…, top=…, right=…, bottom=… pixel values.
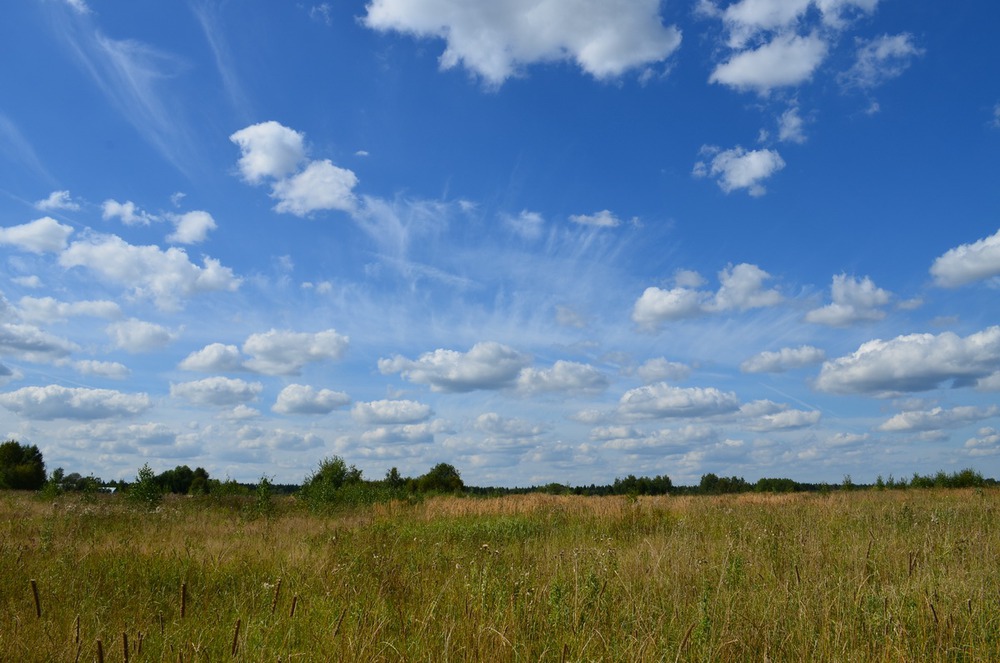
left=816, top=326, right=1000, bottom=395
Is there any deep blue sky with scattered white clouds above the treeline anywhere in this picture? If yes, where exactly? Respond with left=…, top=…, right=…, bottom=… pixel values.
left=0, top=0, right=1000, bottom=486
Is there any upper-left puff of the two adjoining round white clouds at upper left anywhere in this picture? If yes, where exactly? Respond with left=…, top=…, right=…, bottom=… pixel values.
left=229, top=120, right=306, bottom=184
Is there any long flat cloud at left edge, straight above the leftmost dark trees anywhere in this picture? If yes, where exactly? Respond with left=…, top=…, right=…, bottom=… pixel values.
left=0, top=384, right=151, bottom=420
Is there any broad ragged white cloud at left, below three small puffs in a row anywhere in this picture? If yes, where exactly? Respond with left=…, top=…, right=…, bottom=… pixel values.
left=59, top=235, right=240, bottom=309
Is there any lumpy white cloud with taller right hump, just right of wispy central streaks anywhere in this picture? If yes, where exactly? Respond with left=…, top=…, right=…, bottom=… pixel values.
left=632, top=263, right=782, bottom=329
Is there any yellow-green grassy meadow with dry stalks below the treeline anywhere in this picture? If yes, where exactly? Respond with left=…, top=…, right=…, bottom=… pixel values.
left=0, top=489, right=1000, bottom=662
